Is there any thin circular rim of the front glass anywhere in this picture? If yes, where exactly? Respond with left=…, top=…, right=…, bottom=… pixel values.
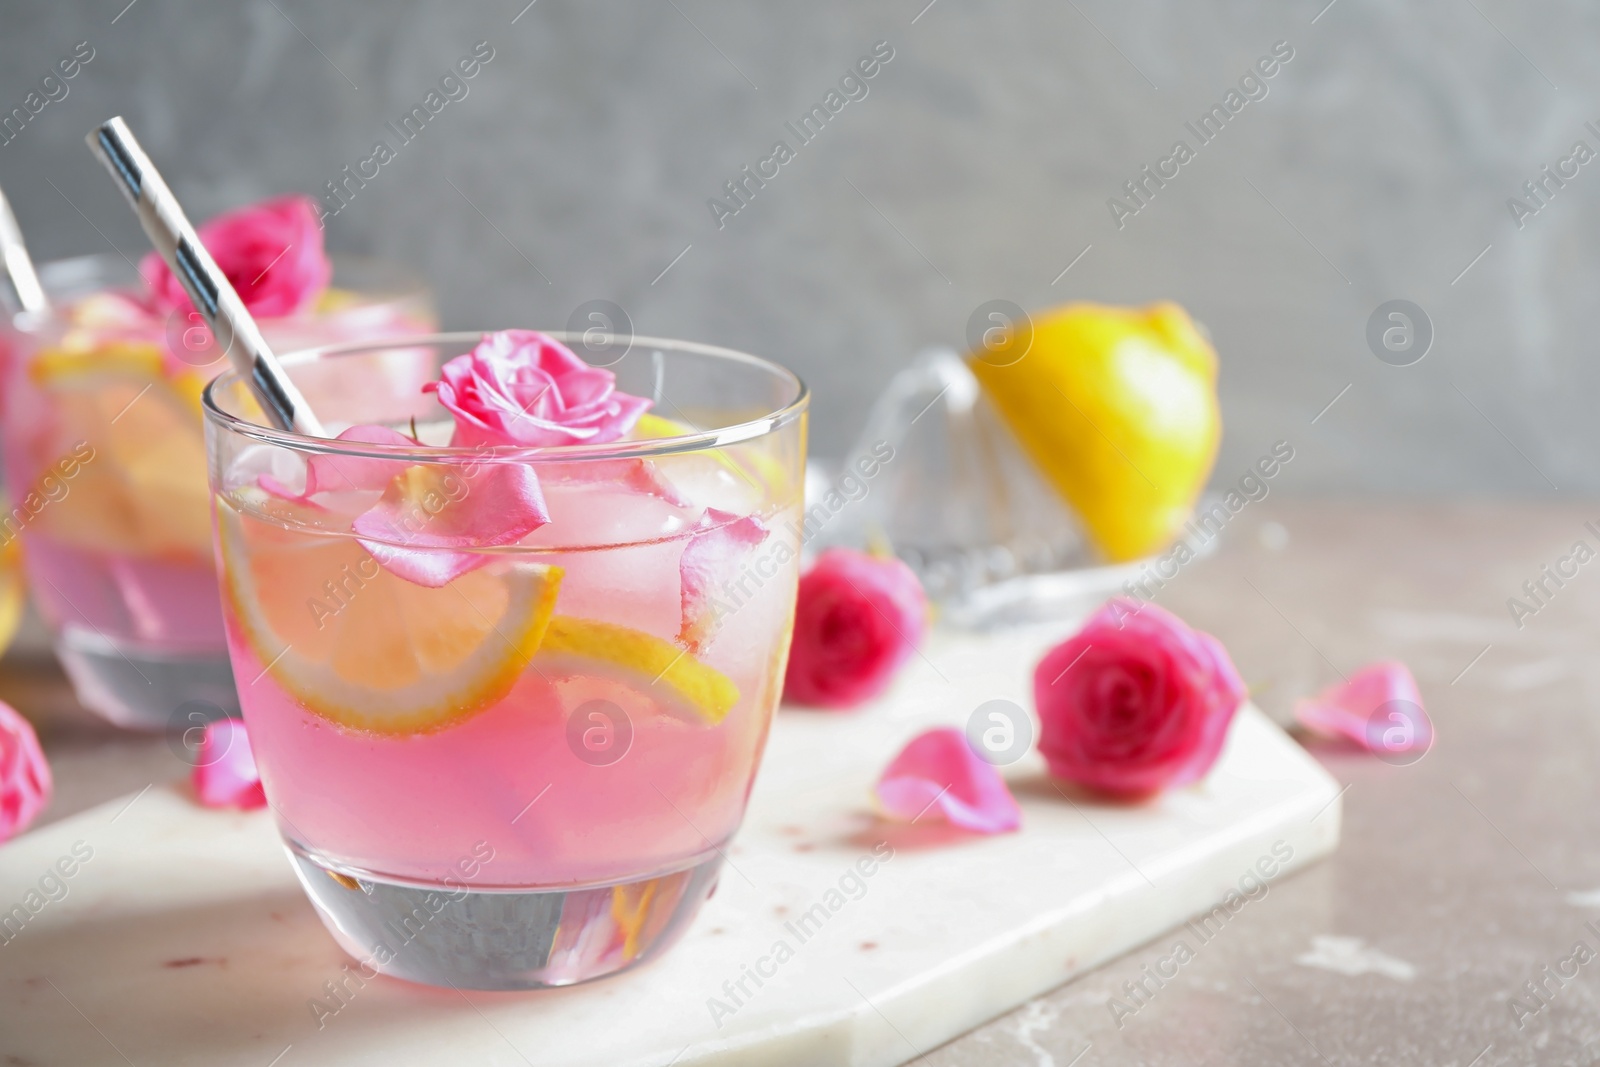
left=200, top=330, right=811, bottom=464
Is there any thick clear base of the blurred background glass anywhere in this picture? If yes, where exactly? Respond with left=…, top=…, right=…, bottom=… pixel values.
left=56, top=625, right=238, bottom=731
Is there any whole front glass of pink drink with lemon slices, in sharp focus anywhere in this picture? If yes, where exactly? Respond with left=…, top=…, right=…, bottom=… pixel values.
left=205, top=331, right=806, bottom=989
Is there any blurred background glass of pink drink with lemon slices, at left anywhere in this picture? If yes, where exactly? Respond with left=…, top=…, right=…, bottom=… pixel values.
left=0, top=256, right=435, bottom=729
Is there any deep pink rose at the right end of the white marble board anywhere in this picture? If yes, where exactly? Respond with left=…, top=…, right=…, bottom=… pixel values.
left=1034, top=597, right=1245, bottom=798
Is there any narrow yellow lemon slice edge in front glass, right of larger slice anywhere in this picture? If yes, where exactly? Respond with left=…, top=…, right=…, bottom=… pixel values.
left=533, top=614, right=739, bottom=726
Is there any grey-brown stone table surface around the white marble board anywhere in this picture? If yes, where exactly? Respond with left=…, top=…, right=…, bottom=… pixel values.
left=0, top=498, right=1600, bottom=1067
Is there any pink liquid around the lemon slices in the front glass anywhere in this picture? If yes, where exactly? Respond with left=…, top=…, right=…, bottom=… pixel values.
left=227, top=485, right=797, bottom=888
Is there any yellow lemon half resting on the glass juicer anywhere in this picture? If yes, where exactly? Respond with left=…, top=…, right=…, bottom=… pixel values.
left=970, top=302, right=1222, bottom=561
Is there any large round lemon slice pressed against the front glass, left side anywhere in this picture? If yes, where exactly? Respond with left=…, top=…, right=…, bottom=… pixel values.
left=216, top=496, right=562, bottom=734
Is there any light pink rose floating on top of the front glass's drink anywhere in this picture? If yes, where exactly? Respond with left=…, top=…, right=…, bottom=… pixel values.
left=422, top=330, right=650, bottom=448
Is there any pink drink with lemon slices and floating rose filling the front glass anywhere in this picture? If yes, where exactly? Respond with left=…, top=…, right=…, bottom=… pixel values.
left=216, top=331, right=800, bottom=921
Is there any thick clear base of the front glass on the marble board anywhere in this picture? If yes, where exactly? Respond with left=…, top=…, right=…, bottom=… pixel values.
left=286, top=841, right=722, bottom=990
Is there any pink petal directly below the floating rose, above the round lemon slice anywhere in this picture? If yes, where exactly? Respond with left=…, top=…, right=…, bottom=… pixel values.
left=352, top=462, right=550, bottom=589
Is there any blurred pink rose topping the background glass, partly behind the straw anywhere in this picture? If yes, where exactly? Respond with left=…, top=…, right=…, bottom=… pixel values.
left=139, top=197, right=333, bottom=318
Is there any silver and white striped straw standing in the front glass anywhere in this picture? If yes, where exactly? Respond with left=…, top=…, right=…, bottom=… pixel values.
left=86, top=115, right=326, bottom=437
